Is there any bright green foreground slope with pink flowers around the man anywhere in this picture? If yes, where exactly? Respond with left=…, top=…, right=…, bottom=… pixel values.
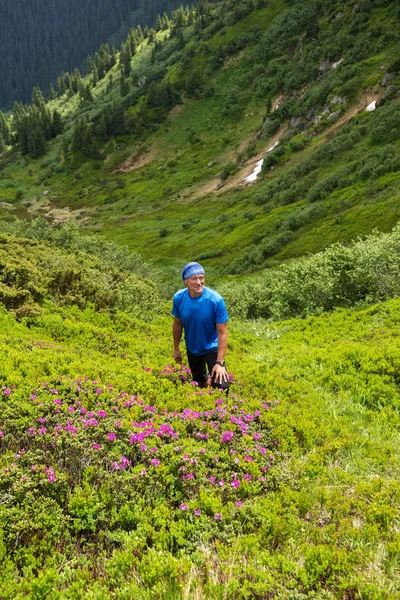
left=0, top=236, right=400, bottom=600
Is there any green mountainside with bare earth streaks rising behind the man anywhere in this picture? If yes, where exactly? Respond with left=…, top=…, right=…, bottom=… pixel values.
left=0, top=0, right=400, bottom=274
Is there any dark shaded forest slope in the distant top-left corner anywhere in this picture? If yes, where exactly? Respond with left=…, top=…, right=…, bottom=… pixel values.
left=0, top=0, right=191, bottom=109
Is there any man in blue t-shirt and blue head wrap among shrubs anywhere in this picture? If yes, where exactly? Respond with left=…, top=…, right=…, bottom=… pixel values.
left=172, top=262, right=229, bottom=390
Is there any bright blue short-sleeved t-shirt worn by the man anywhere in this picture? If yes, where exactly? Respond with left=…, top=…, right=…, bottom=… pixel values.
left=172, top=287, right=228, bottom=354
